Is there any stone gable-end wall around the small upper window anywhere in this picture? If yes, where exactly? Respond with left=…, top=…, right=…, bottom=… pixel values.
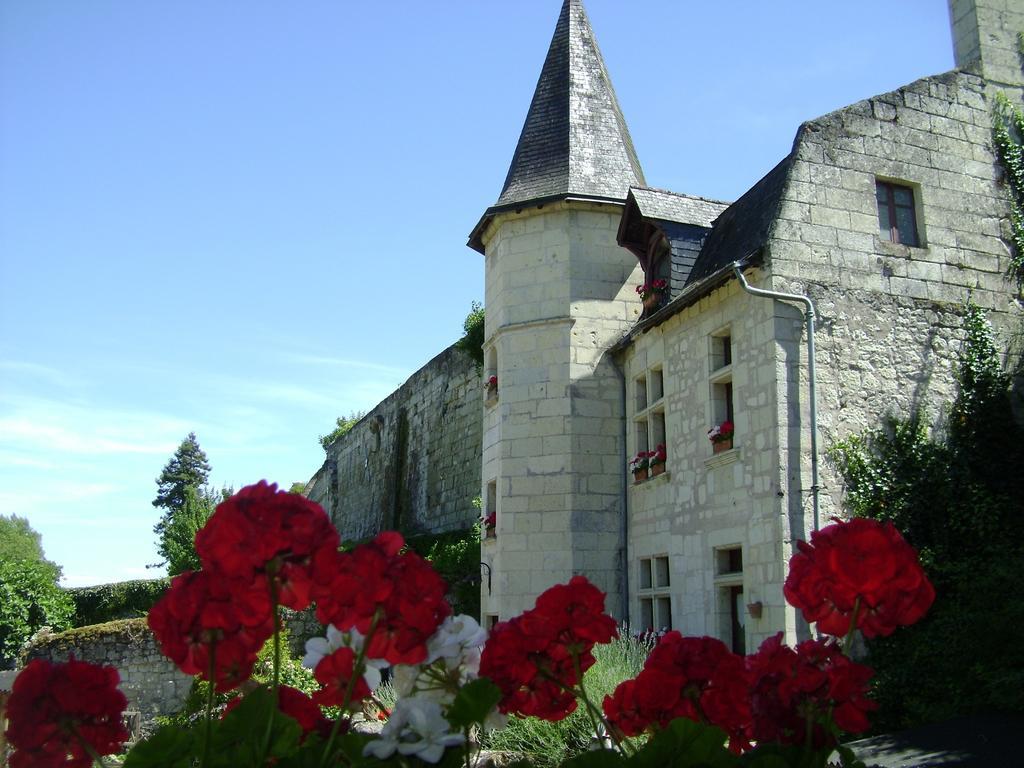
left=768, top=66, right=1021, bottom=536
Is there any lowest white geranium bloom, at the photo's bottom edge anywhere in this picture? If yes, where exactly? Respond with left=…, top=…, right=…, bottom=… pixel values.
left=362, top=696, right=465, bottom=763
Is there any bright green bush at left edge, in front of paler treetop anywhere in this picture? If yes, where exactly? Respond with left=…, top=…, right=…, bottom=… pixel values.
left=0, top=558, right=74, bottom=668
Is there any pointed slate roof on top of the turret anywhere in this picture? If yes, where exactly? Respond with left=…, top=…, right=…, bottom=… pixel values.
left=470, top=0, right=646, bottom=250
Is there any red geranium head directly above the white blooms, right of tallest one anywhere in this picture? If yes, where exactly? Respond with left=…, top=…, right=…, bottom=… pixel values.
left=315, top=531, right=452, bottom=664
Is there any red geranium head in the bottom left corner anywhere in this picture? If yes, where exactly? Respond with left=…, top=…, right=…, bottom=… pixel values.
left=7, top=658, right=128, bottom=768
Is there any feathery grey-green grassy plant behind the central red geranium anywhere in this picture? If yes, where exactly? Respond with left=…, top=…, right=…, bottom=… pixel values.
left=481, top=629, right=655, bottom=768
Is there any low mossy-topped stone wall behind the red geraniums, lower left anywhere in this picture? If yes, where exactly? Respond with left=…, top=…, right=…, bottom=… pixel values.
left=28, top=618, right=193, bottom=722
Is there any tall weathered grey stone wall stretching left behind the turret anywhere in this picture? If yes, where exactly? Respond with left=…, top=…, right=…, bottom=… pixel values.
left=306, top=346, right=483, bottom=541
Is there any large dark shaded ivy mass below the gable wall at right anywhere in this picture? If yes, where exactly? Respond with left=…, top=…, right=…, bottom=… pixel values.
left=830, top=306, right=1024, bottom=730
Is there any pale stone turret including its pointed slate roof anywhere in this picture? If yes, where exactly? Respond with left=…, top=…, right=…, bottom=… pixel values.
left=469, top=0, right=644, bottom=621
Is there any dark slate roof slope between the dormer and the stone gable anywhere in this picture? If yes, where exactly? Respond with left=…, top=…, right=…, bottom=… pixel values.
left=686, top=155, right=793, bottom=285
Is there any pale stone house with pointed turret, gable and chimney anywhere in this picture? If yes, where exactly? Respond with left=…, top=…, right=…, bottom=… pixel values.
left=311, top=0, right=1024, bottom=650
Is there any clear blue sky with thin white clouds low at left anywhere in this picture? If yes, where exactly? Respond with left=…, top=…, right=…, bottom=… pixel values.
left=0, top=0, right=953, bottom=585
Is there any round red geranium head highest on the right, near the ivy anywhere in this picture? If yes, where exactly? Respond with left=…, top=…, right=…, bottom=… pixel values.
left=783, top=517, right=935, bottom=637
